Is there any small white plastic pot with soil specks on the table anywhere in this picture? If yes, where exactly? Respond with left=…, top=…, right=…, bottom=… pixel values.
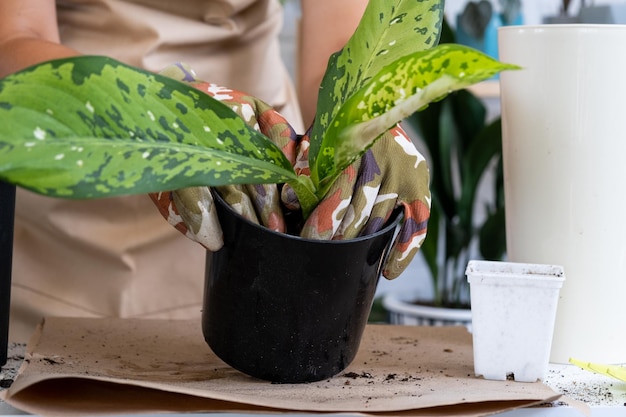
left=465, top=261, right=565, bottom=382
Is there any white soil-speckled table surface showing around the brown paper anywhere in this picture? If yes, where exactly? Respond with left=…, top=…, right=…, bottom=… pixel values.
left=0, top=344, right=626, bottom=417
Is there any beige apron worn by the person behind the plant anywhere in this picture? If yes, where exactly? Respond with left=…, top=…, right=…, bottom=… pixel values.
left=10, top=0, right=302, bottom=341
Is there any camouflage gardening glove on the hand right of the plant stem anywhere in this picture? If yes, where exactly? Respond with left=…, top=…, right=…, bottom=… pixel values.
left=282, top=126, right=430, bottom=279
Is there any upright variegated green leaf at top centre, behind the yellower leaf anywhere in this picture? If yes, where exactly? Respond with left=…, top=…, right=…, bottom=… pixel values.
left=309, top=0, right=443, bottom=181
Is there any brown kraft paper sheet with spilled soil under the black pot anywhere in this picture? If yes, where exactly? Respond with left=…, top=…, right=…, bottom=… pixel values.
left=2, top=318, right=559, bottom=416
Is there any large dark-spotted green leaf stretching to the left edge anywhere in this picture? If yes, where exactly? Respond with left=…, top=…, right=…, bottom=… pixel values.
left=0, top=57, right=296, bottom=198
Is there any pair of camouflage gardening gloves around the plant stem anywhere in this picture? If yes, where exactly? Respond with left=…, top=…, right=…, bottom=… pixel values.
left=151, top=65, right=430, bottom=279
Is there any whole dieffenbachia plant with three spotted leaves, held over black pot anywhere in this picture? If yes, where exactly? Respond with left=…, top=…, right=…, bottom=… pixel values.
left=0, top=0, right=515, bottom=217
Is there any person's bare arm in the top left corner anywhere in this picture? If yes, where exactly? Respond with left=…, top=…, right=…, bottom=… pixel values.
left=0, top=0, right=78, bottom=77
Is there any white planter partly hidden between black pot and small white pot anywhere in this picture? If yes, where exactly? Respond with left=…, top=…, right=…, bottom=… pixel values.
left=383, top=292, right=472, bottom=331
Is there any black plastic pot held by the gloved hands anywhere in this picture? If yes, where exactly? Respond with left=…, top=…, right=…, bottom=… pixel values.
left=202, top=190, right=401, bottom=383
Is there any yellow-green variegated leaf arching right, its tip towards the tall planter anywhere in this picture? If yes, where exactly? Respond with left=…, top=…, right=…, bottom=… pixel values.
left=317, top=44, right=517, bottom=193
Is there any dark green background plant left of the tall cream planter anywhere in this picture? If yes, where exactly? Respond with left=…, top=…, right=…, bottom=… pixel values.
left=406, top=22, right=506, bottom=307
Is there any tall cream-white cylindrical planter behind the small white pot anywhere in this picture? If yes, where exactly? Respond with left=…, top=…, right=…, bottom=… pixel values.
left=498, top=25, right=626, bottom=363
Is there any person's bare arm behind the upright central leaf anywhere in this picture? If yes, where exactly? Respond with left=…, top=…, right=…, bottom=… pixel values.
left=297, top=0, right=367, bottom=127
